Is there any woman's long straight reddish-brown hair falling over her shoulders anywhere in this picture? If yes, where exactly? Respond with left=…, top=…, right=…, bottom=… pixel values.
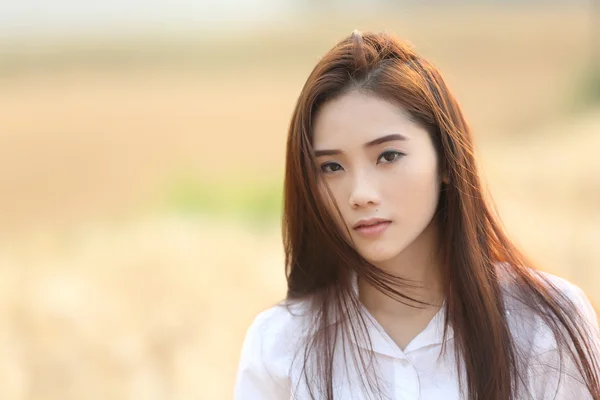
left=283, top=31, right=600, bottom=400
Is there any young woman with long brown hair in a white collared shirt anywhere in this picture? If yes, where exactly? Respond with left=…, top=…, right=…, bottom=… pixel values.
left=235, top=31, right=600, bottom=400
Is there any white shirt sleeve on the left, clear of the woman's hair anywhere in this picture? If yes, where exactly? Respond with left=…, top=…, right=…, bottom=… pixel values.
left=234, top=314, right=289, bottom=400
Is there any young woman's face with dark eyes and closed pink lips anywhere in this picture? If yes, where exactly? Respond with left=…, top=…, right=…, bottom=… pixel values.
left=313, top=91, right=441, bottom=265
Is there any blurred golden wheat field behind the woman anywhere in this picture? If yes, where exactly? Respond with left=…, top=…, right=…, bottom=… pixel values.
left=0, top=8, right=600, bottom=400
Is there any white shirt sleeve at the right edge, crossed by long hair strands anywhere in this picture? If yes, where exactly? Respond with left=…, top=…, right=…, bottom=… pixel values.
left=529, top=284, right=600, bottom=400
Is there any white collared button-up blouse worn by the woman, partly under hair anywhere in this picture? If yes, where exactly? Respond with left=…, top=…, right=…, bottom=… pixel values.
left=234, top=274, right=600, bottom=400
